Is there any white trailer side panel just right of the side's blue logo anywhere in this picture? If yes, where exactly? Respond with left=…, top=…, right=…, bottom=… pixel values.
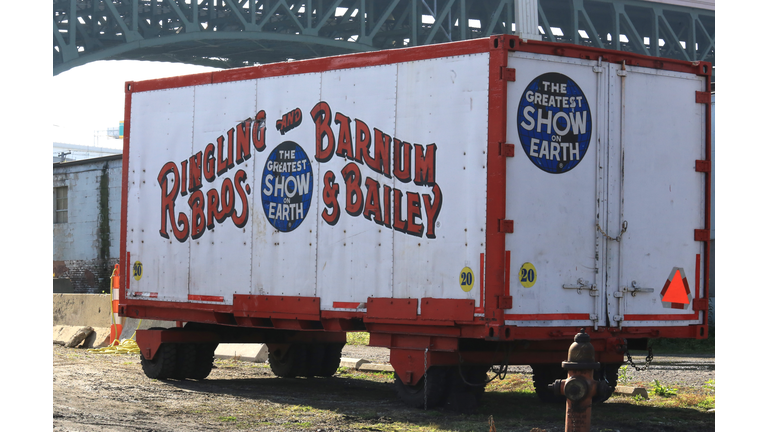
left=317, top=65, right=397, bottom=309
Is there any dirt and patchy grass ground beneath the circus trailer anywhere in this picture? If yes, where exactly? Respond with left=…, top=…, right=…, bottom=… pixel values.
left=53, top=345, right=714, bottom=432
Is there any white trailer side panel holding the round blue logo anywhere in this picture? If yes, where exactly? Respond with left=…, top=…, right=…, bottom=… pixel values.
left=252, top=74, right=320, bottom=296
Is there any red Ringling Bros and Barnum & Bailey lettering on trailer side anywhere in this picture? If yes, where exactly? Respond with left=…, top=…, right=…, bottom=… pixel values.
left=157, top=102, right=443, bottom=242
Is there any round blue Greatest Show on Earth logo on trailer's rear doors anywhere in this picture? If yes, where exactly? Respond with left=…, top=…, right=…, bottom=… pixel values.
left=517, top=72, right=592, bottom=174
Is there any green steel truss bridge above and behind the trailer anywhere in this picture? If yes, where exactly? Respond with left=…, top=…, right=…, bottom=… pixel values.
left=53, top=0, right=715, bottom=75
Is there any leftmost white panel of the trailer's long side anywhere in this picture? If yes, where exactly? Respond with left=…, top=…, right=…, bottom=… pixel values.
left=124, top=88, right=194, bottom=301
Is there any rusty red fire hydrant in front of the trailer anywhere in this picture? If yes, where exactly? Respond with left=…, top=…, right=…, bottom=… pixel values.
left=549, top=329, right=613, bottom=432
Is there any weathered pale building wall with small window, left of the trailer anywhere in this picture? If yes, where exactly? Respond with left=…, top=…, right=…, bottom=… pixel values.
left=52, top=155, right=122, bottom=293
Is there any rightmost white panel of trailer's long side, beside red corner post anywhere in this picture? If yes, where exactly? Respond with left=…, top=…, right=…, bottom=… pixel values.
left=393, top=54, right=489, bottom=306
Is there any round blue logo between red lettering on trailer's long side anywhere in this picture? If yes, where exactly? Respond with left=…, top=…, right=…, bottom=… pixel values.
left=261, top=141, right=312, bottom=232
